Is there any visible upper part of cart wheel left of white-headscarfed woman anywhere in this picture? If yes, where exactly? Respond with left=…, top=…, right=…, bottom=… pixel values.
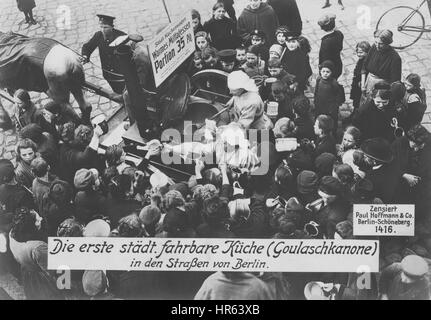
left=191, top=69, right=229, bottom=96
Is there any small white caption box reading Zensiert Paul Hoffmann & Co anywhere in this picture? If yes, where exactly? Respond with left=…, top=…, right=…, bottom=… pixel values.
left=353, top=204, right=415, bottom=237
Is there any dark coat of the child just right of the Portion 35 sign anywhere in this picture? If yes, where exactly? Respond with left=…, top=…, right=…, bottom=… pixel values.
left=204, top=17, right=239, bottom=50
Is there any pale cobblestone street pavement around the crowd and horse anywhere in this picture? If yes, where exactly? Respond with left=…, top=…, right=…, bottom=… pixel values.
left=0, top=0, right=431, bottom=298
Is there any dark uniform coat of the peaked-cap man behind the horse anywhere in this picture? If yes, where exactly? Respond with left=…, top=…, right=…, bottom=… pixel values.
left=81, top=29, right=125, bottom=80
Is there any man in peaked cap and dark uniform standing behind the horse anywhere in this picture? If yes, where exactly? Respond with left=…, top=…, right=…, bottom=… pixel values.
left=81, top=14, right=125, bottom=94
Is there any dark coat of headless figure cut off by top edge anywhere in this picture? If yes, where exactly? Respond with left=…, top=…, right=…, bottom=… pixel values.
left=268, top=0, right=302, bottom=35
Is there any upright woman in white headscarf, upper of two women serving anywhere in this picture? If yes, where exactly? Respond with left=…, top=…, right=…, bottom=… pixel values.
left=227, top=71, right=273, bottom=130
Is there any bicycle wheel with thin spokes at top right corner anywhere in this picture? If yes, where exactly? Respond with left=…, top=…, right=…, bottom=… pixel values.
left=376, top=6, right=425, bottom=49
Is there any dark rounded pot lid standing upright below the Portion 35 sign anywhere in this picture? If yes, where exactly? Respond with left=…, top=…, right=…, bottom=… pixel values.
left=159, top=73, right=190, bottom=128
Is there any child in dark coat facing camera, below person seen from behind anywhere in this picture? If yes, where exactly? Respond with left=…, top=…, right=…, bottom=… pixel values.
left=314, top=61, right=345, bottom=135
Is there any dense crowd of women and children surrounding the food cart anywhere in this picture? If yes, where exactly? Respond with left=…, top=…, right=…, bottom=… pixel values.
left=0, top=0, right=431, bottom=300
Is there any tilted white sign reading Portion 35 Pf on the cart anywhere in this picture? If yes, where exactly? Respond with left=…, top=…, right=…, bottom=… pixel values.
left=148, top=14, right=195, bottom=87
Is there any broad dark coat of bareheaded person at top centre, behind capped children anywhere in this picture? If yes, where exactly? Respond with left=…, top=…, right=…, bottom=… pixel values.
left=237, top=3, right=279, bottom=45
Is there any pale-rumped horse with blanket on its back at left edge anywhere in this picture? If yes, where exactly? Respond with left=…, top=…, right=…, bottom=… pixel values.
left=0, top=31, right=91, bottom=113
